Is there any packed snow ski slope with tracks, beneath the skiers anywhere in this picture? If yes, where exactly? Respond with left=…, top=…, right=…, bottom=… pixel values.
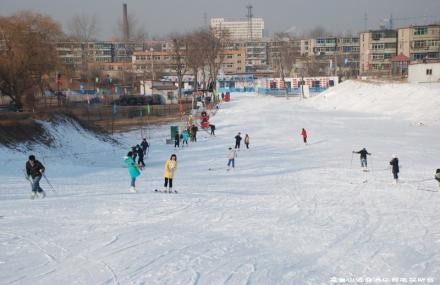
left=0, top=83, right=440, bottom=285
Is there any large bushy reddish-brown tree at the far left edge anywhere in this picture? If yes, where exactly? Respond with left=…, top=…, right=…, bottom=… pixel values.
left=0, top=12, right=62, bottom=109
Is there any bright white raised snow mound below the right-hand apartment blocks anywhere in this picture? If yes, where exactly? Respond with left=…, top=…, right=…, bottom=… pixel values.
left=308, top=80, right=440, bottom=124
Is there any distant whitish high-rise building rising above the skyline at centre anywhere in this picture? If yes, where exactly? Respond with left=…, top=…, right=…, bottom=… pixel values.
left=211, top=18, right=264, bottom=41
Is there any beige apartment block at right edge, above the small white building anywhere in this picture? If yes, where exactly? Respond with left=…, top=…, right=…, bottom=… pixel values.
left=397, top=24, right=440, bottom=61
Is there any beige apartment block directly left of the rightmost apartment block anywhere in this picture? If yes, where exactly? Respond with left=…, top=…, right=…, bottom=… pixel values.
left=359, top=29, right=397, bottom=75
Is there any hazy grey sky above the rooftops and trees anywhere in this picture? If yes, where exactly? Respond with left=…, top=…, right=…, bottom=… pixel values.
left=0, top=0, right=440, bottom=39
